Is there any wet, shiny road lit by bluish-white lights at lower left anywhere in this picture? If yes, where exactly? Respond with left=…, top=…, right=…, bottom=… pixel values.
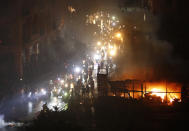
left=0, top=82, right=67, bottom=131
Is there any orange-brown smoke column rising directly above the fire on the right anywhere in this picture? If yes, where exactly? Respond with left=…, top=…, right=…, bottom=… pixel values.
left=113, top=8, right=181, bottom=81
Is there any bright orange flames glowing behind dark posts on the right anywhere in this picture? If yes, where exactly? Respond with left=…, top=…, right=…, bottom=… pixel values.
left=109, top=82, right=182, bottom=105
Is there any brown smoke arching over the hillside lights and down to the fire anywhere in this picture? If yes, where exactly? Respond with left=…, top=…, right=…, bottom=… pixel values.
left=49, top=0, right=188, bottom=81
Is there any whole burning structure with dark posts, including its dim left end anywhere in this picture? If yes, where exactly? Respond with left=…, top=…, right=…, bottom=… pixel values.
left=108, top=80, right=181, bottom=105
